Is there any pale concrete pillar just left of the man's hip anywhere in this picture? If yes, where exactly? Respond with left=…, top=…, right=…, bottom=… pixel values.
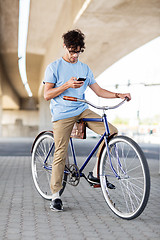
left=39, top=97, right=53, bottom=132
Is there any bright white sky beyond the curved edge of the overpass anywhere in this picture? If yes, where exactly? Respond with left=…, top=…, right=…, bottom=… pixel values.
left=86, top=37, right=160, bottom=124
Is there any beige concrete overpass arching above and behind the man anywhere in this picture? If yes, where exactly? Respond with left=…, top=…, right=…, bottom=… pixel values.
left=0, top=0, right=160, bottom=136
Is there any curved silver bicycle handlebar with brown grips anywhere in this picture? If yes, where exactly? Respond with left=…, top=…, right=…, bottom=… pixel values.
left=63, top=96, right=129, bottom=110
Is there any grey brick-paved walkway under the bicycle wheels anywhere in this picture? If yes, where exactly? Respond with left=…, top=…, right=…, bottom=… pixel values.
left=0, top=156, right=160, bottom=240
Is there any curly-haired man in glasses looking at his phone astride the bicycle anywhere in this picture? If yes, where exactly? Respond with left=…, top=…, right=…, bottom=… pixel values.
left=44, top=29, right=131, bottom=211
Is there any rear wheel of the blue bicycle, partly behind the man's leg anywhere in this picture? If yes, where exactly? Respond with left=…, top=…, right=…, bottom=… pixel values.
left=31, top=132, right=67, bottom=200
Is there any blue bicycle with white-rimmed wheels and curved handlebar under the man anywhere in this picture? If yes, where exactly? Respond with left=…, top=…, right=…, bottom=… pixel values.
left=32, top=96, right=150, bottom=220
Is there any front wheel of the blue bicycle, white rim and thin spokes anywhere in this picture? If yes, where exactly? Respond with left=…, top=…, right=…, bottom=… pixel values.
left=100, top=136, right=150, bottom=220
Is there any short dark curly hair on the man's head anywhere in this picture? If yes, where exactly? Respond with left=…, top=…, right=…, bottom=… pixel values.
left=62, top=29, right=85, bottom=51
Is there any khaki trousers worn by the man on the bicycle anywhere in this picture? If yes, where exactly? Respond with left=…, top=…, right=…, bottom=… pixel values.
left=51, top=109, right=117, bottom=194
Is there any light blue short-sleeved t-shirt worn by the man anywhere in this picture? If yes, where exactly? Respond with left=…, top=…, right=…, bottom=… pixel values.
left=44, top=58, right=96, bottom=121
